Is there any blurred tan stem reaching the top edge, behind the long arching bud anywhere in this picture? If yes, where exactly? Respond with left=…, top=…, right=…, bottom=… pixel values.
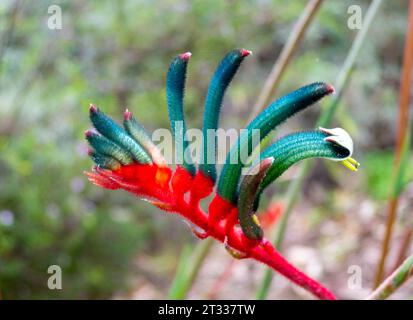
left=248, top=0, right=322, bottom=122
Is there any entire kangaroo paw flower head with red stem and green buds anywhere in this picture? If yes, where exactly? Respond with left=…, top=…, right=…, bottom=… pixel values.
left=85, top=49, right=359, bottom=299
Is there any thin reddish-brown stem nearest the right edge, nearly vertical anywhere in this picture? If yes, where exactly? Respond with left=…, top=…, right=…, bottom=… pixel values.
left=374, top=0, right=413, bottom=287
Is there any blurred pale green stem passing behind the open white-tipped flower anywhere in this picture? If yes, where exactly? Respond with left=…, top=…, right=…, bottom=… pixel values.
left=256, top=0, right=382, bottom=299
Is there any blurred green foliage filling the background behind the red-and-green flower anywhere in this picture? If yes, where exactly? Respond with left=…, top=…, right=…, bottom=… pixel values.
left=0, top=0, right=413, bottom=298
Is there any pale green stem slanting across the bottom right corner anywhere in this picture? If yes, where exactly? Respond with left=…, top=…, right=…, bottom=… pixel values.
left=367, top=256, right=413, bottom=300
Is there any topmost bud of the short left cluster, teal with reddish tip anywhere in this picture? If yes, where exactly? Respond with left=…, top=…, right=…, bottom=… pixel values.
left=89, top=105, right=152, bottom=163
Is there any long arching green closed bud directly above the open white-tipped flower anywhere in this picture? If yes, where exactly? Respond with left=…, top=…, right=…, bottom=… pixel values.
left=218, top=82, right=334, bottom=204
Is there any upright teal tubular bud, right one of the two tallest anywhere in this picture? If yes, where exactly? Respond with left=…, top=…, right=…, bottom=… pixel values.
left=199, top=49, right=251, bottom=182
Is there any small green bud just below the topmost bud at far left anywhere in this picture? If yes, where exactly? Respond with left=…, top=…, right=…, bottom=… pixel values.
left=85, top=130, right=133, bottom=165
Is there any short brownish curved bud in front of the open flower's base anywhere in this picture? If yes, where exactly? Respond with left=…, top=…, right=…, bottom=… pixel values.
left=238, top=157, right=274, bottom=240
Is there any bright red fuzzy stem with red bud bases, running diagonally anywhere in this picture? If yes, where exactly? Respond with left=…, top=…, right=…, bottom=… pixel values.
left=88, top=164, right=335, bottom=300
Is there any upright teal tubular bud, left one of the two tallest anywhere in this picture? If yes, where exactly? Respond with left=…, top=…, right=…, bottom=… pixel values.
left=166, top=52, right=195, bottom=175
